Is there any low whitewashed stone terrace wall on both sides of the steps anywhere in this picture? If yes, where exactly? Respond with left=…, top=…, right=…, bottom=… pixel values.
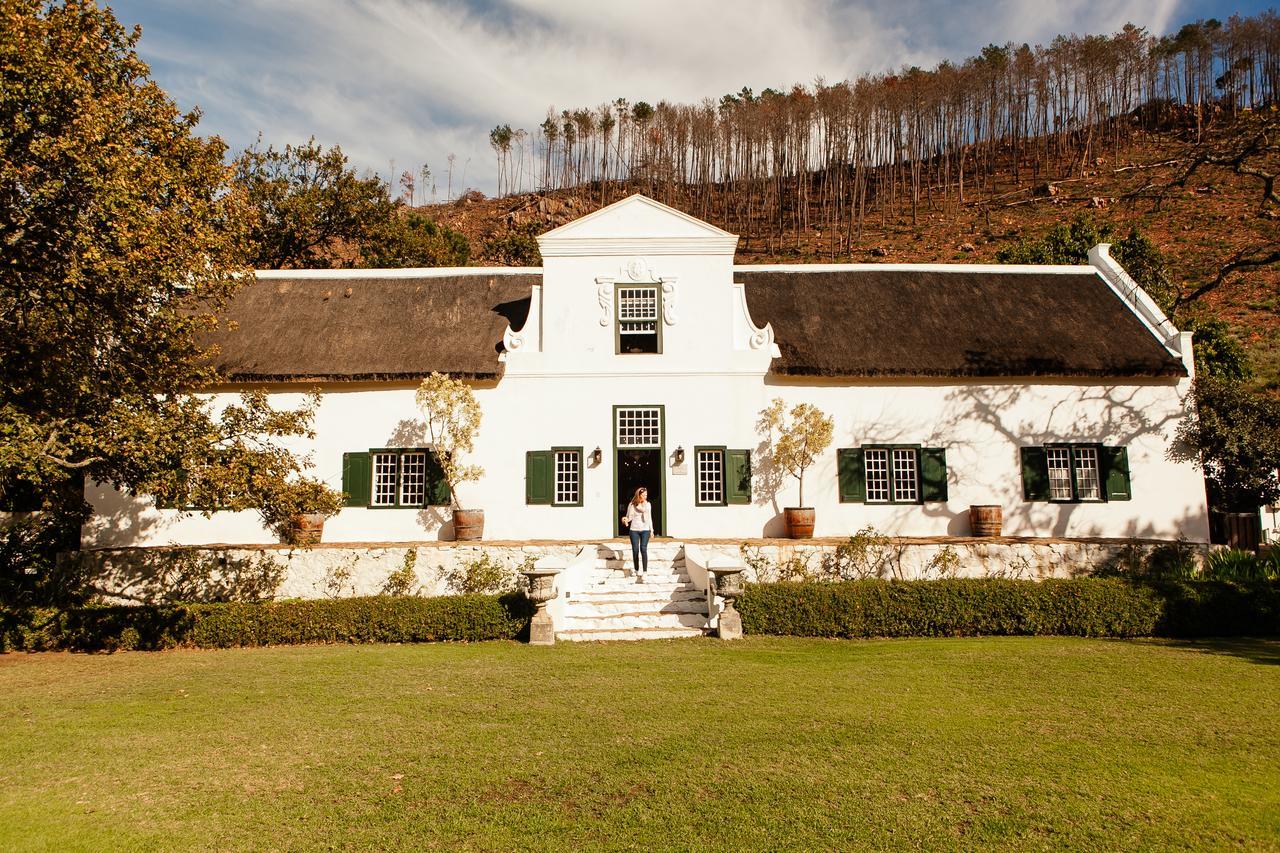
left=72, top=538, right=1207, bottom=603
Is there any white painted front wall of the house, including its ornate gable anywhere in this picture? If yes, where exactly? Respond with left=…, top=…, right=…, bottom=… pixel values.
left=83, top=197, right=1208, bottom=547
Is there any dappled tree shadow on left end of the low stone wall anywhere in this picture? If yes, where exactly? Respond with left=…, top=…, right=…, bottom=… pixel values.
left=81, top=548, right=285, bottom=605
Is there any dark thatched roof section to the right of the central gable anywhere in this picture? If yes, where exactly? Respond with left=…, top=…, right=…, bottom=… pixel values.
left=733, top=266, right=1185, bottom=377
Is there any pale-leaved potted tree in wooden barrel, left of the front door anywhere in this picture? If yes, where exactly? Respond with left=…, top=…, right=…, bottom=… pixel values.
left=417, top=373, right=484, bottom=540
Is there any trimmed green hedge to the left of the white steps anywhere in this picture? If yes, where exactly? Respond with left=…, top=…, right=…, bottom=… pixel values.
left=0, top=593, right=531, bottom=652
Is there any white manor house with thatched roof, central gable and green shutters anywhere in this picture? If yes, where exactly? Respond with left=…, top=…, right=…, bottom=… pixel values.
left=83, top=195, right=1208, bottom=548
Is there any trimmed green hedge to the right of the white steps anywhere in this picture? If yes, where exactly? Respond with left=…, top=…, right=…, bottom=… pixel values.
left=737, top=578, right=1280, bottom=637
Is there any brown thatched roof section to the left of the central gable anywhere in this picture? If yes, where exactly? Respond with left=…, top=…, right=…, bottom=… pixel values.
left=209, top=270, right=541, bottom=382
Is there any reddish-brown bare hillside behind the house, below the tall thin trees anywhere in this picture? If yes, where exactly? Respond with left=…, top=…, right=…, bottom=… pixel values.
left=421, top=126, right=1280, bottom=384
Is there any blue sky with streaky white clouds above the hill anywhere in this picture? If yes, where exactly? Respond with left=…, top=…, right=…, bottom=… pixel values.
left=109, top=0, right=1274, bottom=199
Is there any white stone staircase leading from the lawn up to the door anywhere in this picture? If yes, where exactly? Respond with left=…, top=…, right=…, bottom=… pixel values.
left=556, top=542, right=708, bottom=640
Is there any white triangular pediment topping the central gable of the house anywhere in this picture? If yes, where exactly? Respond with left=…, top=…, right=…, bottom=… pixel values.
left=538, top=195, right=737, bottom=257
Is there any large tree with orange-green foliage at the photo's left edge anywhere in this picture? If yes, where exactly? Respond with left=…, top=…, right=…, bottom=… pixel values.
left=0, top=0, right=332, bottom=597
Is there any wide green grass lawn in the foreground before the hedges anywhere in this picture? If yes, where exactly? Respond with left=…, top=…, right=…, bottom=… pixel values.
left=0, top=638, right=1280, bottom=850
